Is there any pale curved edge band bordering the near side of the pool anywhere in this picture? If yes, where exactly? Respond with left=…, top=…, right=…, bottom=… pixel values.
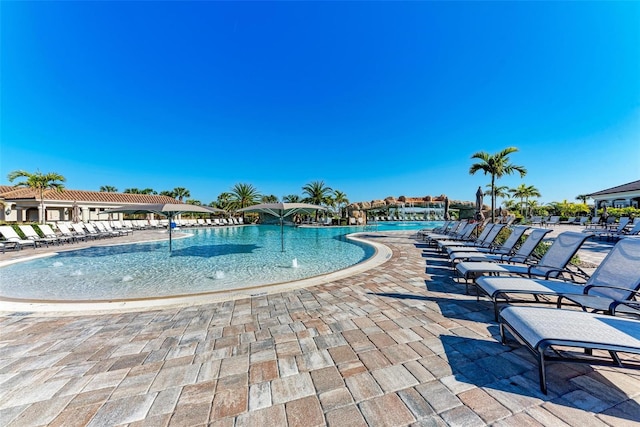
left=0, top=232, right=393, bottom=316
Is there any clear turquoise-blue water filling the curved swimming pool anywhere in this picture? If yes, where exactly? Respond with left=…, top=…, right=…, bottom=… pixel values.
left=0, top=222, right=440, bottom=300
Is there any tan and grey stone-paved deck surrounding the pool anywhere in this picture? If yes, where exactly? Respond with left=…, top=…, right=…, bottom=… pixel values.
left=0, top=227, right=640, bottom=427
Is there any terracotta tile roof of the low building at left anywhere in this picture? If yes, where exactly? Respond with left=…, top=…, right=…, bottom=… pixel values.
left=0, top=185, right=176, bottom=205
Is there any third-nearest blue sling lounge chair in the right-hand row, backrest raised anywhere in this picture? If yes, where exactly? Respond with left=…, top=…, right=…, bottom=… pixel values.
left=456, top=231, right=591, bottom=291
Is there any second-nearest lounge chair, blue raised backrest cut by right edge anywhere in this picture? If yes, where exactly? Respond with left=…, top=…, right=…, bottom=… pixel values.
left=476, top=238, right=640, bottom=320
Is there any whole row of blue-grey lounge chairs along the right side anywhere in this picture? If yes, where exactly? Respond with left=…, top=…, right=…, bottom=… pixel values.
left=421, top=227, right=640, bottom=394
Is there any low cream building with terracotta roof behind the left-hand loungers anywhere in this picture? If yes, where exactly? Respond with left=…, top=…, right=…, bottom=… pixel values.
left=0, top=185, right=177, bottom=222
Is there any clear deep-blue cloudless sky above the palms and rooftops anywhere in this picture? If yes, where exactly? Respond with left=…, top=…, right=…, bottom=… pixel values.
left=0, top=1, right=640, bottom=203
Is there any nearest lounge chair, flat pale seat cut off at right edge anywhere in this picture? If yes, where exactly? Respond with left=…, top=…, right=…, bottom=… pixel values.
left=500, top=306, right=640, bottom=394
